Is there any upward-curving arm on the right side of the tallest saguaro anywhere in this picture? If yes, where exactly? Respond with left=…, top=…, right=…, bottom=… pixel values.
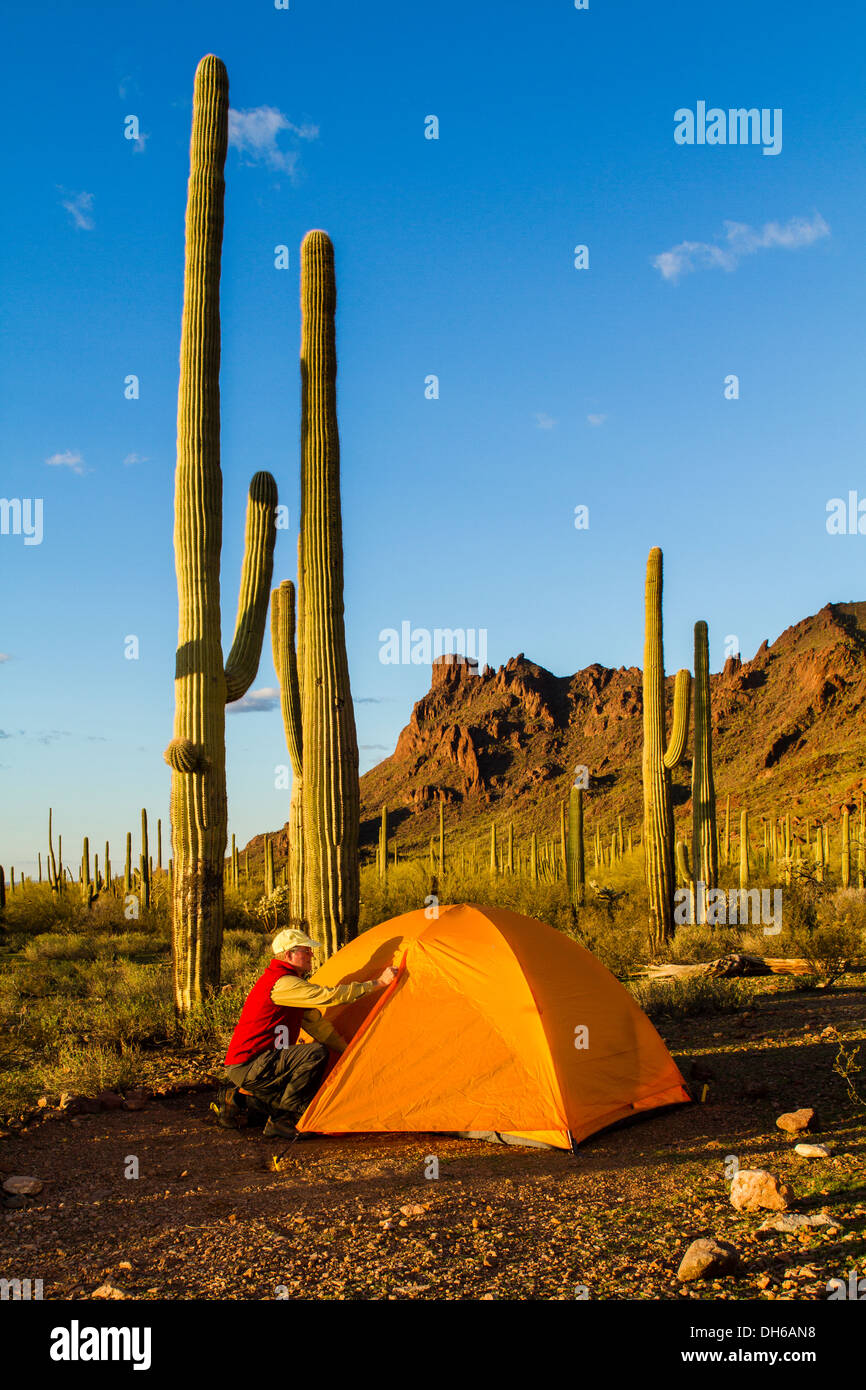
left=225, top=473, right=277, bottom=705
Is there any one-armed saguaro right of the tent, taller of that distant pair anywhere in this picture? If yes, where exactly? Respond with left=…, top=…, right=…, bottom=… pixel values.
left=644, top=546, right=691, bottom=948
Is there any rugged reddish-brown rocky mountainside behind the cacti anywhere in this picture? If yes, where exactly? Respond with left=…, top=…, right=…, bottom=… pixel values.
left=250, top=603, right=866, bottom=858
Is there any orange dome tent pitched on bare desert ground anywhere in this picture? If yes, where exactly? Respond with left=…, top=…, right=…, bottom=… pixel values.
left=297, top=904, right=689, bottom=1148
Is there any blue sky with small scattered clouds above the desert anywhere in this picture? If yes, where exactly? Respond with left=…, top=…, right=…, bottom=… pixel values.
left=0, top=0, right=866, bottom=873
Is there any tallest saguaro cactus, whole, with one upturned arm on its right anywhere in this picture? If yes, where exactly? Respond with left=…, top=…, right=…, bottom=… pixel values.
left=165, top=54, right=277, bottom=1012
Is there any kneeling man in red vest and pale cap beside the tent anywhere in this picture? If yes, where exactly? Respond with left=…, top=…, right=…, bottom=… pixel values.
left=220, top=922, right=396, bottom=1138
